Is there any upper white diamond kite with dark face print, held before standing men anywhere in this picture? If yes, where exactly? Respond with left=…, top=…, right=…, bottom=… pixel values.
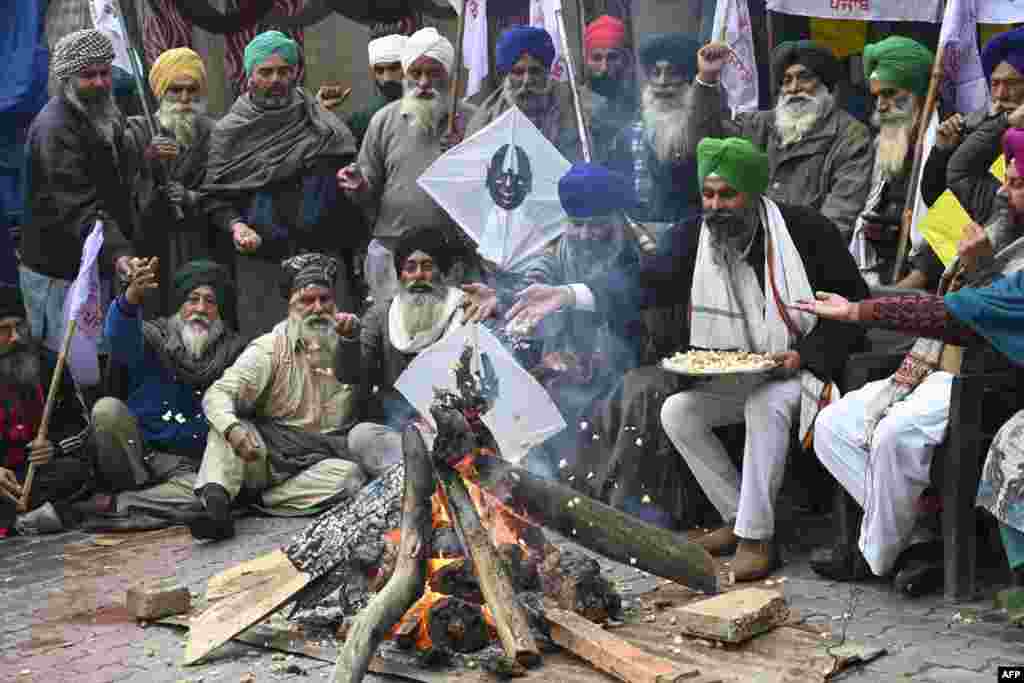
left=418, top=106, right=571, bottom=269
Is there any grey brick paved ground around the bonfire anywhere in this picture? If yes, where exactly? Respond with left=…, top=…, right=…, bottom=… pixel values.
left=0, top=509, right=1024, bottom=683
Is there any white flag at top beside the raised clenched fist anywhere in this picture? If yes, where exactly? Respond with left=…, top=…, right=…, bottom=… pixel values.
left=712, top=0, right=758, bottom=116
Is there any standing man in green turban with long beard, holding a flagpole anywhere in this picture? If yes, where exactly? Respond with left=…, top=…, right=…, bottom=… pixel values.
left=850, top=36, right=942, bottom=289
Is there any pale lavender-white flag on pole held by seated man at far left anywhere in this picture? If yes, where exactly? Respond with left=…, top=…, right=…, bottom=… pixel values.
left=63, top=220, right=103, bottom=386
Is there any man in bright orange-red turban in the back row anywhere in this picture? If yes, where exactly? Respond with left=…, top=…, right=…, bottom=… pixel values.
left=584, top=14, right=639, bottom=159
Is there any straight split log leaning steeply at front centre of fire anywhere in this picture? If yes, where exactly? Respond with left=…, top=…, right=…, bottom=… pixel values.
left=435, top=454, right=541, bottom=667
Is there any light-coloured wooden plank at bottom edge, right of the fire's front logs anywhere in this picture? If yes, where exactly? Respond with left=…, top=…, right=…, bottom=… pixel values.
left=545, top=608, right=699, bottom=683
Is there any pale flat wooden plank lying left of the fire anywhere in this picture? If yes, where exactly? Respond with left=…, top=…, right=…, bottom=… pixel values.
left=184, top=550, right=312, bottom=666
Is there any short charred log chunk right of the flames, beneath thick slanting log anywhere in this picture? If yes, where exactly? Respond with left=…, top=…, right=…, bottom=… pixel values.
left=541, top=548, right=623, bottom=624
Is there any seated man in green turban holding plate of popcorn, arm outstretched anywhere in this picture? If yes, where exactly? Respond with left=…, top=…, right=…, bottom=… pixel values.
left=510, top=138, right=867, bottom=581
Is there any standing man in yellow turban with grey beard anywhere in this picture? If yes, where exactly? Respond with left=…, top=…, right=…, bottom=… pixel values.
left=128, top=47, right=214, bottom=316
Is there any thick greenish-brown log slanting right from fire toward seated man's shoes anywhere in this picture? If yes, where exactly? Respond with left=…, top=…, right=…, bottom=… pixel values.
left=476, top=457, right=720, bottom=595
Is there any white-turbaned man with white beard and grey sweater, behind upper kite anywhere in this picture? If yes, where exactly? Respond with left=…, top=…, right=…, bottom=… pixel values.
left=338, top=28, right=474, bottom=301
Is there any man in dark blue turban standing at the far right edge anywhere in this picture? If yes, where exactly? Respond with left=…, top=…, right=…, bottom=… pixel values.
left=921, top=29, right=1024, bottom=224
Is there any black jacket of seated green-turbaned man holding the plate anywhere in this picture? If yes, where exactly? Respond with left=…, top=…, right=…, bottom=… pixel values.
left=586, top=204, right=868, bottom=380
